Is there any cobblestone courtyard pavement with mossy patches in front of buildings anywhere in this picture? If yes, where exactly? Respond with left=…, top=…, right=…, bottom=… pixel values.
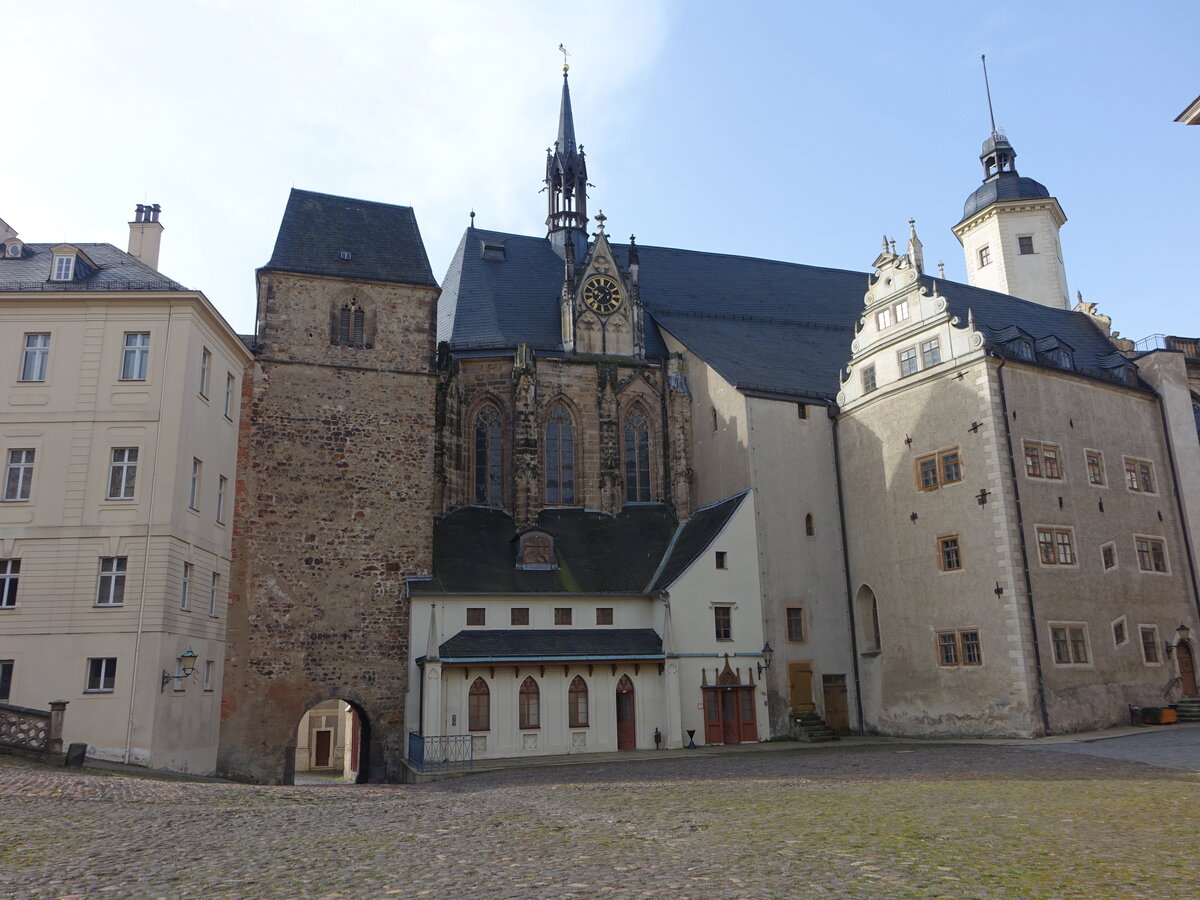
left=0, top=744, right=1200, bottom=900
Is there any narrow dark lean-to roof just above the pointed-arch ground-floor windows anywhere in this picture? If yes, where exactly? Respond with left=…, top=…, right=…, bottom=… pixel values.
left=429, top=628, right=662, bottom=664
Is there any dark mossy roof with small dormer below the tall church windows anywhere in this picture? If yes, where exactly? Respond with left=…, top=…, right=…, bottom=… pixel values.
left=412, top=503, right=676, bottom=594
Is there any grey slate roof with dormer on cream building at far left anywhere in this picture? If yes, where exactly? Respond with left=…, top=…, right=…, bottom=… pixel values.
left=0, top=241, right=187, bottom=290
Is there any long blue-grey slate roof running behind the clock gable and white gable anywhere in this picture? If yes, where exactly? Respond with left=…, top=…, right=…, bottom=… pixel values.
left=438, top=229, right=1132, bottom=401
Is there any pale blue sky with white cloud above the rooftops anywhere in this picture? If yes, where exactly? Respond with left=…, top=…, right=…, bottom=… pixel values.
left=0, top=0, right=1200, bottom=340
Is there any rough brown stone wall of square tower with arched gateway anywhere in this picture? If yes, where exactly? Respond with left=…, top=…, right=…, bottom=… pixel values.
left=218, top=274, right=437, bottom=782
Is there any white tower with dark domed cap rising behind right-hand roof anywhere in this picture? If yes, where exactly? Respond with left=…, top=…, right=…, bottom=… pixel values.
left=953, top=131, right=1070, bottom=310
